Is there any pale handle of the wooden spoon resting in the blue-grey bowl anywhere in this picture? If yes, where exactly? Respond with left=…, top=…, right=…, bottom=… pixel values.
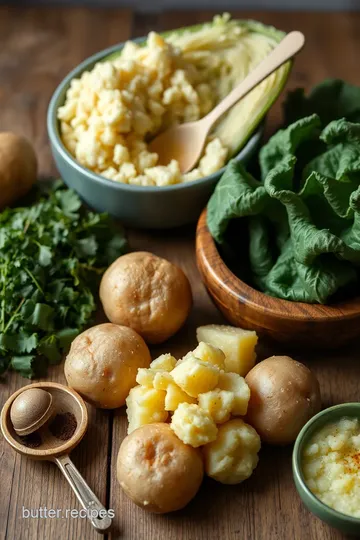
left=202, top=31, right=305, bottom=129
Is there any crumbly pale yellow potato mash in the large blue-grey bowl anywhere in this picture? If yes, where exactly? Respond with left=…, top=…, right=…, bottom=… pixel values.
left=58, top=32, right=227, bottom=186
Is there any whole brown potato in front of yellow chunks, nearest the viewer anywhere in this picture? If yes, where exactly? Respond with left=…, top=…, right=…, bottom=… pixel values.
left=116, top=423, right=204, bottom=514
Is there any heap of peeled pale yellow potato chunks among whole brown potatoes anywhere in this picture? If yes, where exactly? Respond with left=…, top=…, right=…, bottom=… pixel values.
left=126, top=327, right=260, bottom=484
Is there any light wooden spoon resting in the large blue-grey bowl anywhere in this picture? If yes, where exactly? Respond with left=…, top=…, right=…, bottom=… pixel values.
left=149, top=31, right=305, bottom=173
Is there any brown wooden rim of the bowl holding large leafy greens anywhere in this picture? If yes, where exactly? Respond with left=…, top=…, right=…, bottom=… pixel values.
left=196, top=208, right=360, bottom=323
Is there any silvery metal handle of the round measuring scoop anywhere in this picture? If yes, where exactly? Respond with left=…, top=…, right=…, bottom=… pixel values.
left=55, top=455, right=112, bottom=534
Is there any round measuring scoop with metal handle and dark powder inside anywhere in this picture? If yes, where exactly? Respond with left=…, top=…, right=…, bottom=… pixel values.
left=0, top=382, right=111, bottom=533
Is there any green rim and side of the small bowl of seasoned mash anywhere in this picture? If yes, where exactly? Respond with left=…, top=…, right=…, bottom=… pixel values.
left=292, top=401, right=360, bottom=526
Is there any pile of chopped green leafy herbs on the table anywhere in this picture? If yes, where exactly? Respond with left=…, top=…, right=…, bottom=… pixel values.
left=0, top=182, right=126, bottom=377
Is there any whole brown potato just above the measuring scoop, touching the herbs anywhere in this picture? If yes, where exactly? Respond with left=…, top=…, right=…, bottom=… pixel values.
left=64, top=323, right=151, bottom=409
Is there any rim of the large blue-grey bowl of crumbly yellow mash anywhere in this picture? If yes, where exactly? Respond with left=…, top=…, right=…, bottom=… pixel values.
left=46, top=36, right=264, bottom=193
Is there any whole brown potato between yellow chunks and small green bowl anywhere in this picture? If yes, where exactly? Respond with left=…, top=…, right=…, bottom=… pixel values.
left=245, top=356, right=321, bottom=445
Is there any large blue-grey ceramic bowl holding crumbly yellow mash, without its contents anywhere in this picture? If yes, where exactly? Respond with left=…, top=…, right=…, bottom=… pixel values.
left=47, top=38, right=263, bottom=229
